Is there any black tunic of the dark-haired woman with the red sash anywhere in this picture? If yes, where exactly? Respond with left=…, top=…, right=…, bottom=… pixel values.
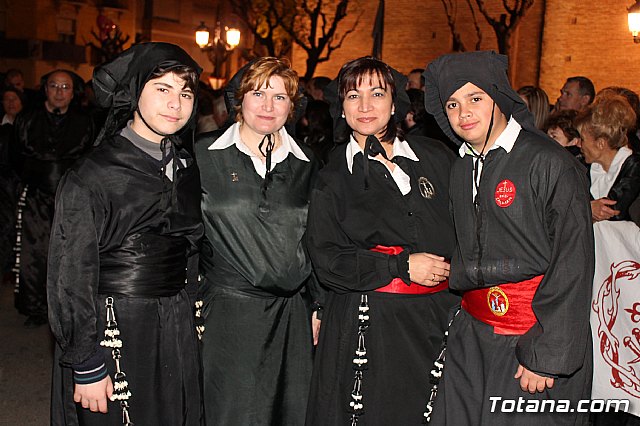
left=306, top=137, right=458, bottom=426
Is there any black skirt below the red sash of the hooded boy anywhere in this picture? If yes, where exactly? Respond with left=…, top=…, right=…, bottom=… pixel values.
left=430, top=309, right=593, bottom=426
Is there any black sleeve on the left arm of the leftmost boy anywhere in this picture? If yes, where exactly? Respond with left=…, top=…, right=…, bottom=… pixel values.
left=47, top=172, right=105, bottom=365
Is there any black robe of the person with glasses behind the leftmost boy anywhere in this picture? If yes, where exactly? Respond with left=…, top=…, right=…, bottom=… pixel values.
left=11, top=107, right=94, bottom=316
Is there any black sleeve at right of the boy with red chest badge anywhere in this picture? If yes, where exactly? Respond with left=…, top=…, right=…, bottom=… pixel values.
left=516, top=163, right=594, bottom=376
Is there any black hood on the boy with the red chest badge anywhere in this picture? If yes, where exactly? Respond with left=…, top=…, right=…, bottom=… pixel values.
left=423, top=51, right=543, bottom=145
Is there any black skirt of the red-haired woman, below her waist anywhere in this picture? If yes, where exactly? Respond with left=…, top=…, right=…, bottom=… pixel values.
left=202, top=283, right=313, bottom=426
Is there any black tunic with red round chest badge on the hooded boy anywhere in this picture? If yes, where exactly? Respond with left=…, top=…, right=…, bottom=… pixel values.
left=431, top=129, right=594, bottom=426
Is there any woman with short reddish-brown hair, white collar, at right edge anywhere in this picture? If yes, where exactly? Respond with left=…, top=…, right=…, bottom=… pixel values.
left=575, top=92, right=640, bottom=222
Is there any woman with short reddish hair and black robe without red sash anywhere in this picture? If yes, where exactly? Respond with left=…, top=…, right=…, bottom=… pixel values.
left=196, top=57, right=320, bottom=426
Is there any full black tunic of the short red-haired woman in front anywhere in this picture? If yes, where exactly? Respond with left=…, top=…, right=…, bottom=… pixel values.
left=196, top=125, right=319, bottom=426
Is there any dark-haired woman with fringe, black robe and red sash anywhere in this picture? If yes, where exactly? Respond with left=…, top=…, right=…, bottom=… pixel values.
left=307, top=57, right=458, bottom=426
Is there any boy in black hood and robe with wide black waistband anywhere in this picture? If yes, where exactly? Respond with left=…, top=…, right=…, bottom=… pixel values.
left=47, top=43, right=202, bottom=426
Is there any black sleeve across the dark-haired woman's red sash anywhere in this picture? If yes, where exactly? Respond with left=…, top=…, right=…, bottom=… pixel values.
left=307, top=178, right=409, bottom=293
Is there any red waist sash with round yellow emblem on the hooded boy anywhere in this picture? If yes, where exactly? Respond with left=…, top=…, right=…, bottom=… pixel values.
left=462, top=275, right=544, bottom=336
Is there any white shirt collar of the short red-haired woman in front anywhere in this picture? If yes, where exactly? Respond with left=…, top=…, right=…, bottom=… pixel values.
left=209, top=123, right=309, bottom=177
